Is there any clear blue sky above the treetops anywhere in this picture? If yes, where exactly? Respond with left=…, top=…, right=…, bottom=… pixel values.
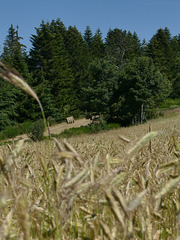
left=0, top=0, right=180, bottom=52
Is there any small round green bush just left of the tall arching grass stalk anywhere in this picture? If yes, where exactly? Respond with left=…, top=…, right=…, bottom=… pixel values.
left=28, top=119, right=45, bottom=142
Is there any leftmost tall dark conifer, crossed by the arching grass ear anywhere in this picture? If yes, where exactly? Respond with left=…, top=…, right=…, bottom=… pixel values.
left=1, top=25, right=31, bottom=126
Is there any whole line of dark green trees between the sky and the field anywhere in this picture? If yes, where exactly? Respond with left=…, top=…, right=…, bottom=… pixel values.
left=0, top=19, right=180, bottom=130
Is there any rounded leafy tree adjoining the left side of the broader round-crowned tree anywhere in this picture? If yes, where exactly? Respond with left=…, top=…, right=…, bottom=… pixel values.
left=83, top=58, right=118, bottom=119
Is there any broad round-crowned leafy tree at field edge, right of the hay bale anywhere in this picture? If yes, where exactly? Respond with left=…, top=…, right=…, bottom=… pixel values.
left=112, top=57, right=171, bottom=125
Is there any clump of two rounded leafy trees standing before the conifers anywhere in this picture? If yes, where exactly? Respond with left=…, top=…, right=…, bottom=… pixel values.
left=83, top=54, right=171, bottom=125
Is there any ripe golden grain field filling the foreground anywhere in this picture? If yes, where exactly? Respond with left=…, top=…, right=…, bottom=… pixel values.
left=0, top=113, right=180, bottom=240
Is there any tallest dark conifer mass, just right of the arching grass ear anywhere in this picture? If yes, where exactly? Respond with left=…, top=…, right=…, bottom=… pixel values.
left=29, top=19, right=77, bottom=120
